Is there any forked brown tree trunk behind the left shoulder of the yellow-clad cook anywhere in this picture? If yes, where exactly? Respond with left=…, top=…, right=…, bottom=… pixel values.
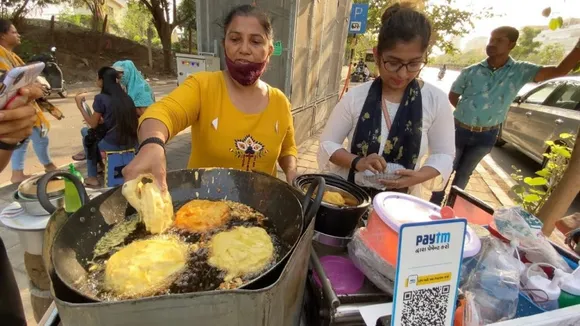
left=139, top=0, right=195, bottom=72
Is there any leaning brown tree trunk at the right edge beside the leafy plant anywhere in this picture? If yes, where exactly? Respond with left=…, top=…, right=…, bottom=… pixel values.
left=538, top=129, right=580, bottom=236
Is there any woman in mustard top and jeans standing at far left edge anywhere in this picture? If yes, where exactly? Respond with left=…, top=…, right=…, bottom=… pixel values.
left=0, top=19, right=63, bottom=183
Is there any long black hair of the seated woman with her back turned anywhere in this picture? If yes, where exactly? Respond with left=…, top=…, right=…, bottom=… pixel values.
left=97, top=67, right=139, bottom=146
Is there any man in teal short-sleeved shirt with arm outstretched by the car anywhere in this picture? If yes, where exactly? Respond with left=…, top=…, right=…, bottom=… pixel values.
left=431, top=26, right=580, bottom=205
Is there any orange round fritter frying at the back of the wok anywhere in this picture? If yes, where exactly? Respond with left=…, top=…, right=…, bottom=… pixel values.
left=175, top=199, right=231, bottom=233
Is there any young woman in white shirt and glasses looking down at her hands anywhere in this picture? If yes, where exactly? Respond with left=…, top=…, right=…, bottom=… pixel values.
left=318, top=4, right=455, bottom=196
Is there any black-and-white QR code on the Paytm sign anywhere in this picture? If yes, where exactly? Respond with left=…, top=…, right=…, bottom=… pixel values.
left=401, top=285, right=450, bottom=326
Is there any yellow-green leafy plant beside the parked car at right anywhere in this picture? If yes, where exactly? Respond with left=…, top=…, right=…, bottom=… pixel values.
left=511, top=133, right=576, bottom=215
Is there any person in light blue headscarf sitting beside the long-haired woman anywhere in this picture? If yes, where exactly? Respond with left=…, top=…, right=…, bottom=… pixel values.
left=113, top=60, right=155, bottom=115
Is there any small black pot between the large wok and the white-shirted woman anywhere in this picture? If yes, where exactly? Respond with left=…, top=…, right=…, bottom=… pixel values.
left=293, top=174, right=372, bottom=237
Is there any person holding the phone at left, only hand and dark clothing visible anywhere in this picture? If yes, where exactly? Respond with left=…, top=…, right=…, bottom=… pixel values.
left=0, top=85, right=43, bottom=326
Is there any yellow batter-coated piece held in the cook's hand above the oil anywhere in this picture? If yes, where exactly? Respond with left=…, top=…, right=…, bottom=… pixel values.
left=122, top=174, right=173, bottom=234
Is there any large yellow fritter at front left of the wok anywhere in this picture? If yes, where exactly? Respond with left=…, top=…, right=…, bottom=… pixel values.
left=104, top=235, right=188, bottom=298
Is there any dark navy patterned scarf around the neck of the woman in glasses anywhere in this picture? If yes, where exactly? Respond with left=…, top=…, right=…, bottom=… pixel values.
left=348, top=78, right=423, bottom=182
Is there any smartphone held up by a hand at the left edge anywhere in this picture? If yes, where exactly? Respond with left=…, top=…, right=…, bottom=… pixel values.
left=0, top=62, right=44, bottom=110
